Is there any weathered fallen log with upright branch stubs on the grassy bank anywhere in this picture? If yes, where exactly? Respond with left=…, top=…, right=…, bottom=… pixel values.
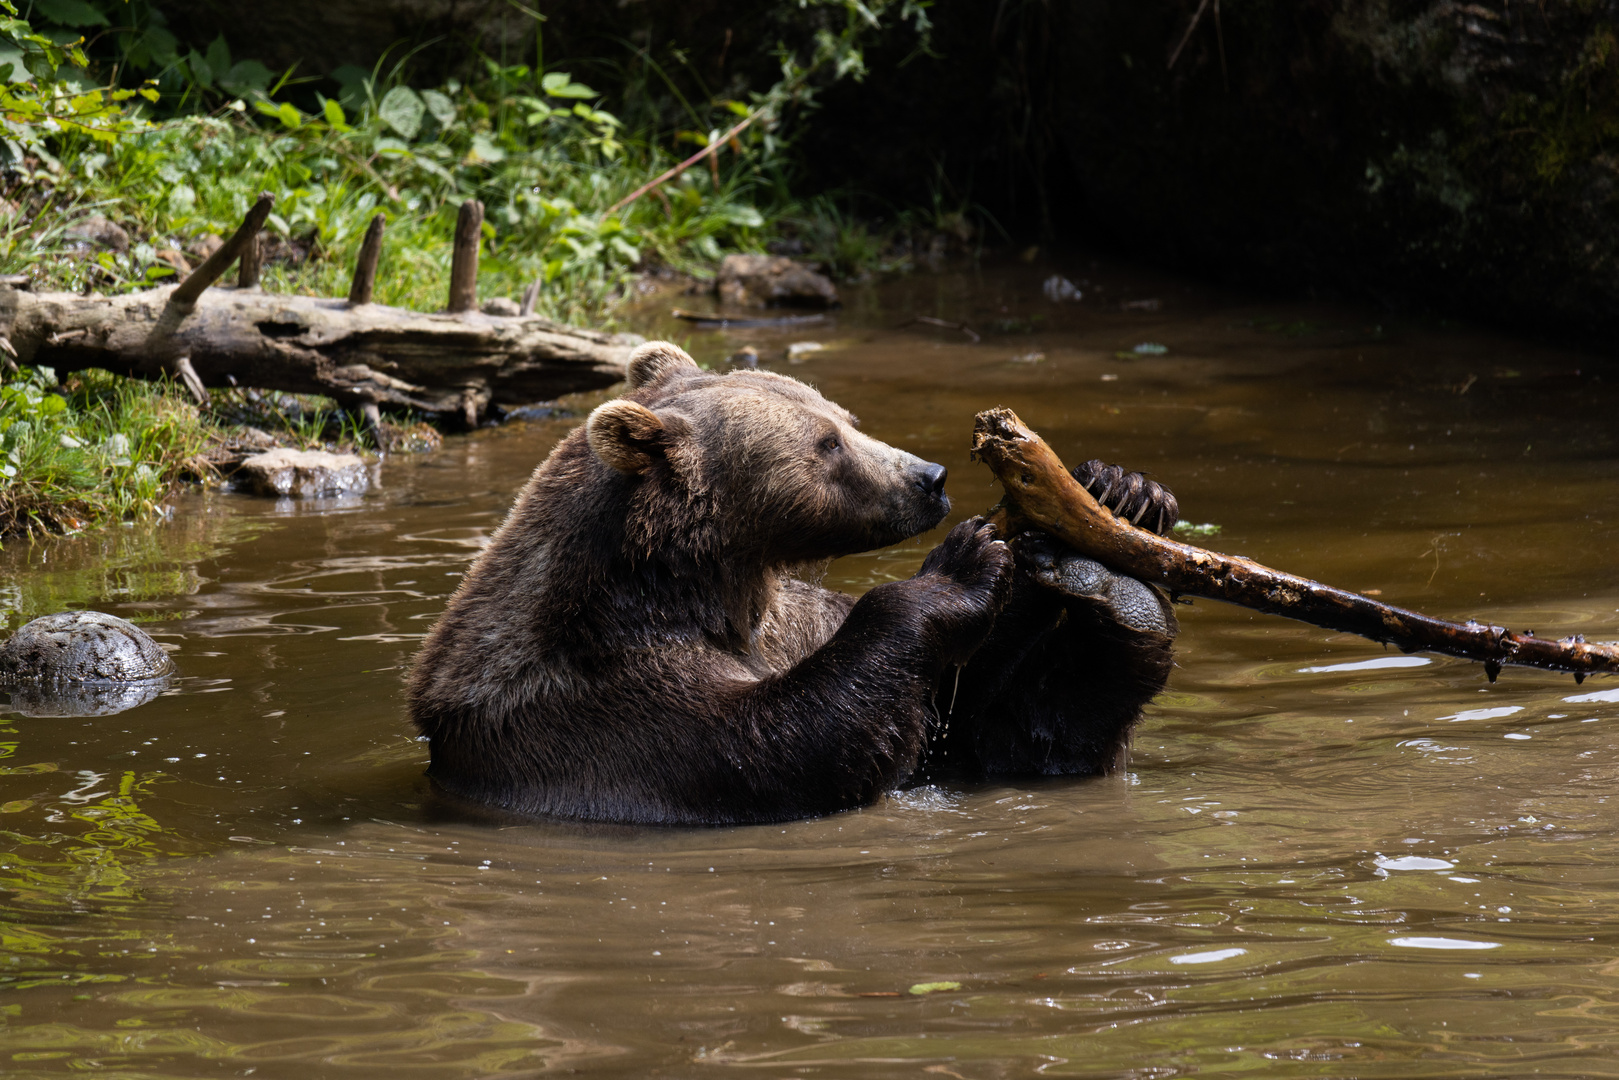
left=0, top=194, right=640, bottom=424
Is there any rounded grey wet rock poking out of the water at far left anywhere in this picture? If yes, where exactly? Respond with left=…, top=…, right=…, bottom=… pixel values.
left=0, top=612, right=175, bottom=685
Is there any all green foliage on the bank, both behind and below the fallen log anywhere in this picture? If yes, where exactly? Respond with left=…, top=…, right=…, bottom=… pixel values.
left=0, top=0, right=928, bottom=534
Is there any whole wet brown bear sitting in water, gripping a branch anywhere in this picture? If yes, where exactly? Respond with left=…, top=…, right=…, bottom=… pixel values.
left=408, top=342, right=1175, bottom=824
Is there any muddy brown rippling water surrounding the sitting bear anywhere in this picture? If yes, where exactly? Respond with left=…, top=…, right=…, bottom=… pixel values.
left=0, top=264, right=1619, bottom=1080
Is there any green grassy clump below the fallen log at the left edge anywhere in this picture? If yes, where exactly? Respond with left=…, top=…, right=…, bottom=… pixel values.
left=0, top=368, right=206, bottom=536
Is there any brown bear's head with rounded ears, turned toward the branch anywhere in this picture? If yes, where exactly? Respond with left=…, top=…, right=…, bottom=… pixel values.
left=586, top=342, right=950, bottom=562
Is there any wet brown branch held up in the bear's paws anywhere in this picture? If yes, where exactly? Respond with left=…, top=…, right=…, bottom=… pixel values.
left=973, top=408, right=1619, bottom=682
